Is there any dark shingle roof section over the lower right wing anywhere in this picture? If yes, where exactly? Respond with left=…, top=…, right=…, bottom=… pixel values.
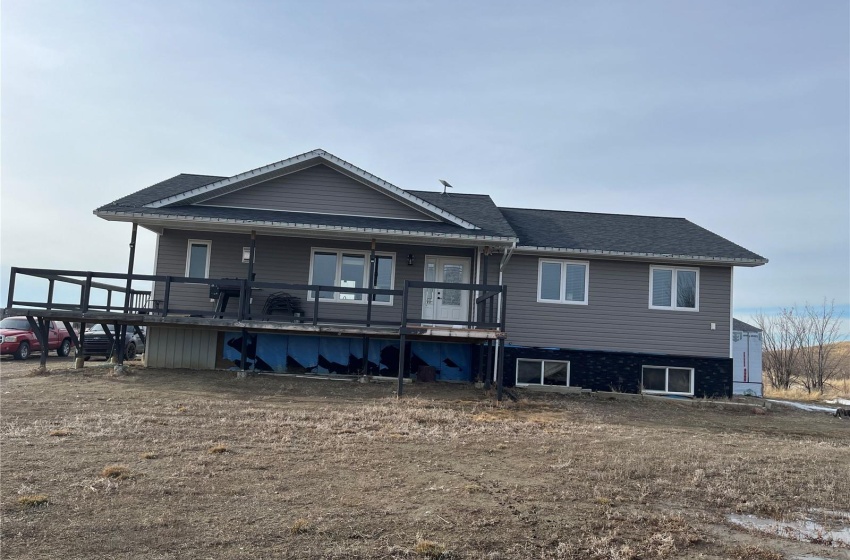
left=500, top=208, right=764, bottom=260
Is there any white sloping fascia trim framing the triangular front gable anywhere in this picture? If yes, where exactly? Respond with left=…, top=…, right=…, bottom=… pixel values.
left=145, top=150, right=481, bottom=229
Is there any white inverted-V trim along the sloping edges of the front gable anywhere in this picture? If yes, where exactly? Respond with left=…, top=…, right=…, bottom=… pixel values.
left=145, top=150, right=479, bottom=229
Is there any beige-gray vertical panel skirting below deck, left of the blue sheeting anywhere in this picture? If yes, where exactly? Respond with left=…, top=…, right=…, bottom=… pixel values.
left=144, top=326, right=218, bottom=369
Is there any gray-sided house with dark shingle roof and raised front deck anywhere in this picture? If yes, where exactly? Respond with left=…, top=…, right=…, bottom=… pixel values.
left=7, top=150, right=767, bottom=396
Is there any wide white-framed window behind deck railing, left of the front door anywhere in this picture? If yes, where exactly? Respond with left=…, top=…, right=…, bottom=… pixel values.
left=308, top=248, right=395, bottom=305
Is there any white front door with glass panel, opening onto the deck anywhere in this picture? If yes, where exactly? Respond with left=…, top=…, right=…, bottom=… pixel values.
left=422, top=257, right=471, bottom=322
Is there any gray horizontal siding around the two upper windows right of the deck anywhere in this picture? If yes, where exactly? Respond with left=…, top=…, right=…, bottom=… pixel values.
left=500, top=255, right=731, bottom=358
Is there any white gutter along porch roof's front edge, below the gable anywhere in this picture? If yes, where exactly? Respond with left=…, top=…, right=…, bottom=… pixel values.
left=94, top=209, right=516, bottom=244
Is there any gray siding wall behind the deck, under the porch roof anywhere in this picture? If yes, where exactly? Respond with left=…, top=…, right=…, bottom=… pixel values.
left=154, top=230, right=473, bottom=322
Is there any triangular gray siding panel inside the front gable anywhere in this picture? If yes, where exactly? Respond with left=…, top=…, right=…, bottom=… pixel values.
left=202, top=165, right=433, bottom=220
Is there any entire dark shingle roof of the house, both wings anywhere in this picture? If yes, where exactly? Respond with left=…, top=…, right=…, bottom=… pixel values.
left=98, top=166, right=766, bottom=262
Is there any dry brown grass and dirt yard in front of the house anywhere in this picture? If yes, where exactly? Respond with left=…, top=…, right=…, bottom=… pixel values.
left=0, top=361, right=850, bottom=559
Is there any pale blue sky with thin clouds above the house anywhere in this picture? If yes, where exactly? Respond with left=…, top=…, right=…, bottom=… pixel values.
left=0, top=0, right=850, bottom=330
